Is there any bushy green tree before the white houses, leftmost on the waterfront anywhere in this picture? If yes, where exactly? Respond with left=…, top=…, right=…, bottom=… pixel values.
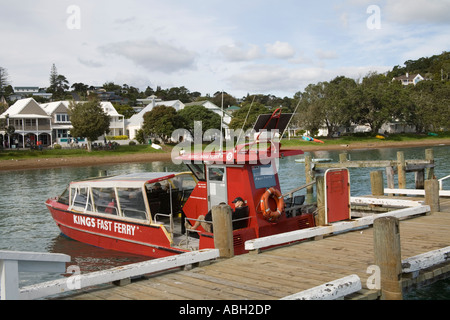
left=69, top=100, right=110, bottom=152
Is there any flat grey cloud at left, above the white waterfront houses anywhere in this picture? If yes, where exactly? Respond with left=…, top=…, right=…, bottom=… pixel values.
left=99, top=39, right=196, bottom=73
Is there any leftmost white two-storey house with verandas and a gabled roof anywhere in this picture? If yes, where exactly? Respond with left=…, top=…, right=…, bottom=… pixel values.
left=0, top=98, right=52, bottom=148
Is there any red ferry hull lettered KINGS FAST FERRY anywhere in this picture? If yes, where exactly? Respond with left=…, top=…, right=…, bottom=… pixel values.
left=46, top=200, right=188, bottom=258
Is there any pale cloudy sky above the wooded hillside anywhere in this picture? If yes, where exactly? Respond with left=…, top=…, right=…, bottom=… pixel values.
left=0, top=0, right=450, bottom=97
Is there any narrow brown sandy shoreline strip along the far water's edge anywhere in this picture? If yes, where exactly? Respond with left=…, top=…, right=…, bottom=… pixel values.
left=0, top=139, right=450, bottom=173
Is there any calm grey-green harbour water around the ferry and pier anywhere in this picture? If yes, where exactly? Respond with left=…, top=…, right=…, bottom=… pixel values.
left=0, top=146, right=450, bottom=299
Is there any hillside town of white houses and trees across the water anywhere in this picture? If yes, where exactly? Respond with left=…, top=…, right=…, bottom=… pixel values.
left=0, top=52, right=450, bottom=148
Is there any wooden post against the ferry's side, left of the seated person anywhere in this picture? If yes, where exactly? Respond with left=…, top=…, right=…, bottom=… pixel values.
left=212, top=205, right=234, bottom=258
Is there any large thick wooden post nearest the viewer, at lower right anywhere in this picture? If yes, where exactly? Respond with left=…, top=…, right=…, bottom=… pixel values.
left=373, top=217, right=403, bottom=300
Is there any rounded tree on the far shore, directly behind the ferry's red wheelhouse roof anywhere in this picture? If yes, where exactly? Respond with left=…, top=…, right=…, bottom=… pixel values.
left=178, top=106, right=221, bottom=137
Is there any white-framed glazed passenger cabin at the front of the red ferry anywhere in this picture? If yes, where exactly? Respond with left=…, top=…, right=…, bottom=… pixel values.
left=58, top=172, right=197, bottom=229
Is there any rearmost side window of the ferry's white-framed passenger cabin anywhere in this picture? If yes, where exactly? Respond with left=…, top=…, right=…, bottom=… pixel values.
left=117, top=188, right=147, bottom=220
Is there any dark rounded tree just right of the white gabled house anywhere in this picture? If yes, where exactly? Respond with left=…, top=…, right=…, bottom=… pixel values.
left=142, top=106, right=186, bottom=143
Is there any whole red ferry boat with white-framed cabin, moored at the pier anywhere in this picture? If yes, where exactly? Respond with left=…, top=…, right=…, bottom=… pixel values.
left=46, top=109, right=314, bottom=258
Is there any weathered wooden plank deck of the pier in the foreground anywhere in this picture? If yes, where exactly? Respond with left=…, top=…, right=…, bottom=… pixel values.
left=64, top=198, right=450, bottom=300
